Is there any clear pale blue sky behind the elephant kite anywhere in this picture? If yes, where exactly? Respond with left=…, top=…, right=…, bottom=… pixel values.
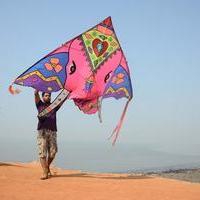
left=0, top=0, right=200, bottom=158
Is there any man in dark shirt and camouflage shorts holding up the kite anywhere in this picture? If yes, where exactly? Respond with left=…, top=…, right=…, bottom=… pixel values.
left=35, top=90, right=61, bottom=180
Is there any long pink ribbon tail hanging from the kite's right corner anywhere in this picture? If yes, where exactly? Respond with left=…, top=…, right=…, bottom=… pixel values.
left=109, top=99, right=130, bottom=146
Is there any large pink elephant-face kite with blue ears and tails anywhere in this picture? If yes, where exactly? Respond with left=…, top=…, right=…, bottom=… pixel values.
left=9, top=17, right=132, bottom=144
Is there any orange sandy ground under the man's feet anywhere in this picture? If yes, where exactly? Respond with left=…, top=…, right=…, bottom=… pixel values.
left=0, top=162, right=200, bottom=200
